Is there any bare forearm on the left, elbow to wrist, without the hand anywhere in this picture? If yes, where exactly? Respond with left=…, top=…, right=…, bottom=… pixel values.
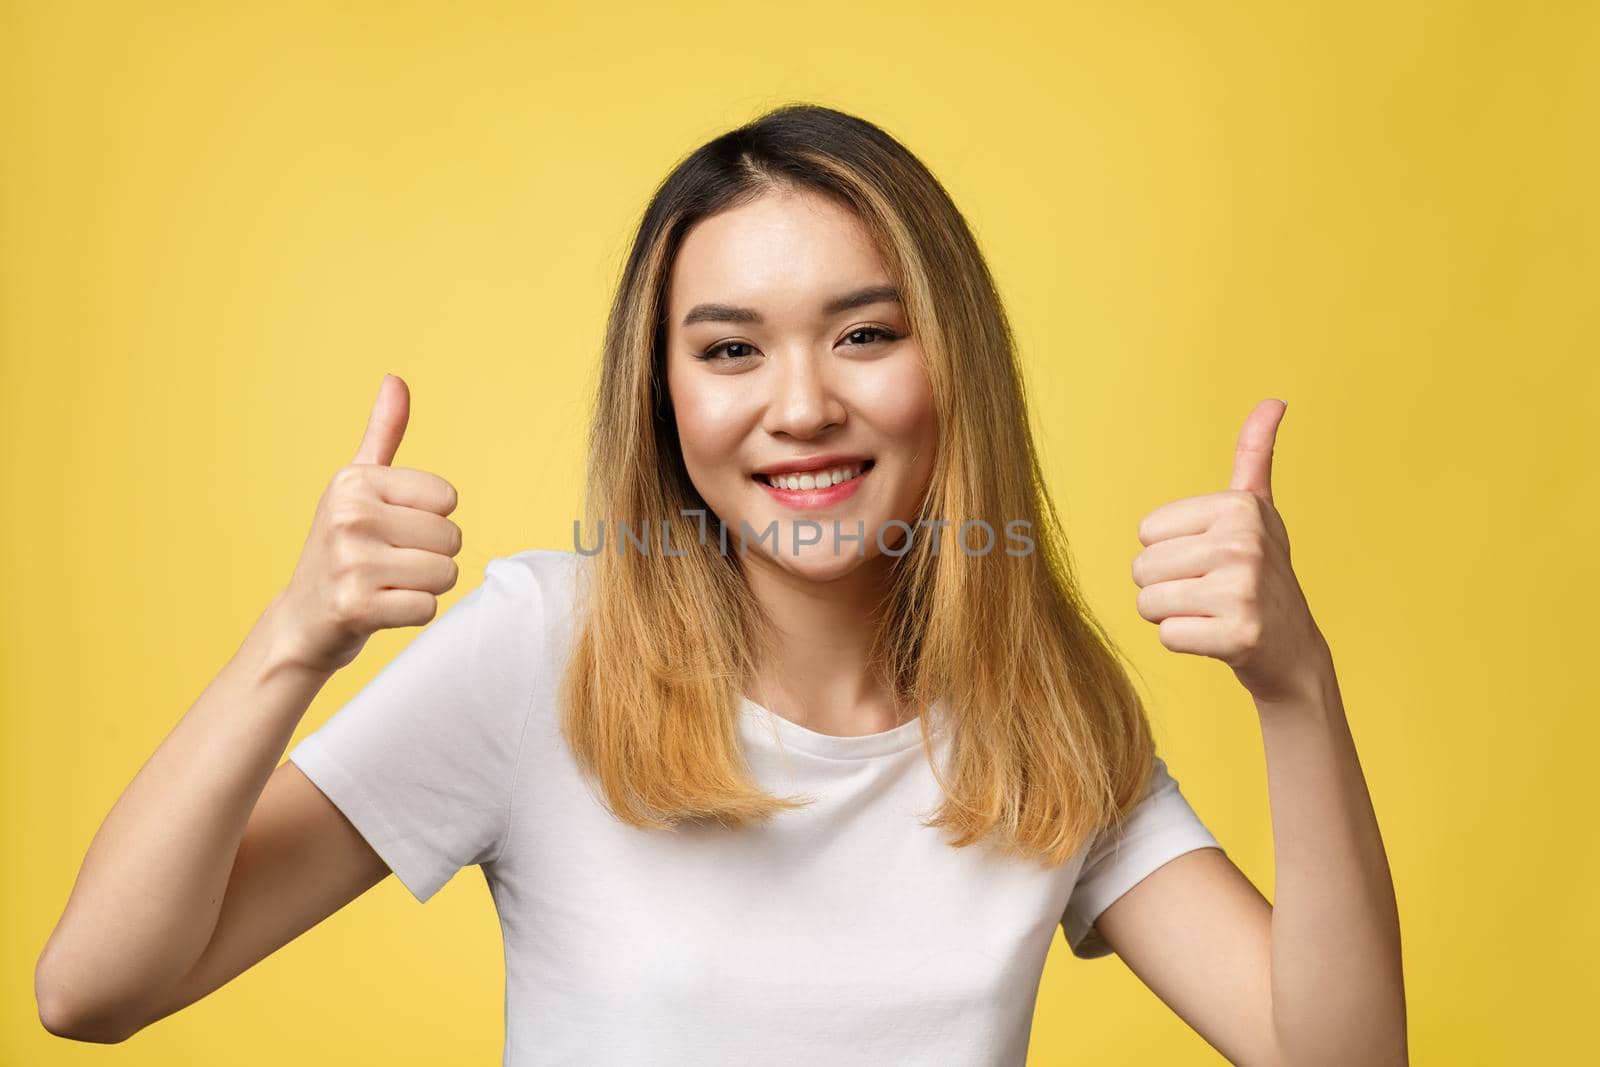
left=35, top=588, right=330, bottom=1040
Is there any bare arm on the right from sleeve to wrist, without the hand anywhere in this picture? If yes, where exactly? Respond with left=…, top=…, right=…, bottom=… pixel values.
left=1094, top=655, right=1410, bottom=1065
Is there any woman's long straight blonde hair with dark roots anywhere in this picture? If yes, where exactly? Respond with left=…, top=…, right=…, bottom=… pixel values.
left=560, top=104, right=1154, bottom=865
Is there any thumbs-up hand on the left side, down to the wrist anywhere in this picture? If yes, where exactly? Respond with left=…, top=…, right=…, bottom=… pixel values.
left=277, top=374, right=461, bottom=673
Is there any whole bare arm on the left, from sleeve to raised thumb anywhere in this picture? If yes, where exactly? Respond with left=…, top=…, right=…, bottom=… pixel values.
left=34, top=376, right=461, bottom=1041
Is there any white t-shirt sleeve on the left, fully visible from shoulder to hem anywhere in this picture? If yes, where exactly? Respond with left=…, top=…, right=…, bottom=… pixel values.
left=288, top=558, right=542, bottom=902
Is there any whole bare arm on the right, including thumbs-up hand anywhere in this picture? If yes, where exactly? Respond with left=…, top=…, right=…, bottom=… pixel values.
left=1099, top=400, right=1410, bottom=1067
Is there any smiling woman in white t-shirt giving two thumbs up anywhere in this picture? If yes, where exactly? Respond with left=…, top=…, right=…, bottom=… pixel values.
left=37, top=107, right=1405, bottom=1064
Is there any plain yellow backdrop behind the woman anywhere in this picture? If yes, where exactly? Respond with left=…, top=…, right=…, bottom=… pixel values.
left=0, top=0, right=1600, bottom=1065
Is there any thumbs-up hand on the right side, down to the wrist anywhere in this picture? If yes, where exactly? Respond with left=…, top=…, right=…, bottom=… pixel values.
left=1133, top=400, right=1331, bottom=704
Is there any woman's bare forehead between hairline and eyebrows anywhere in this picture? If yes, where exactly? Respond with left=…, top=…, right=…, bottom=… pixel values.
left=667, top=190, right=888, bottom=316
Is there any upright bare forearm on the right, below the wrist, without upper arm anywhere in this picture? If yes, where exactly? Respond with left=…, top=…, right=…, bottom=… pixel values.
left=1256, top=646, right=1408, bottom=1067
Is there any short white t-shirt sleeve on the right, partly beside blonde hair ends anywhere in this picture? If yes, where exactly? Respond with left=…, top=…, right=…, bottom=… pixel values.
left=1061, top=757, right=1222, bottom=960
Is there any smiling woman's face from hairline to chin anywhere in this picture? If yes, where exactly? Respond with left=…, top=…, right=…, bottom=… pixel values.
left=667, top=190, right=938, bottom=581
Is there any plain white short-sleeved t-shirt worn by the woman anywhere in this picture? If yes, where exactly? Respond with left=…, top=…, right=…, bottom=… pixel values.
left=290, top=549, right=1219, bottom=1067
